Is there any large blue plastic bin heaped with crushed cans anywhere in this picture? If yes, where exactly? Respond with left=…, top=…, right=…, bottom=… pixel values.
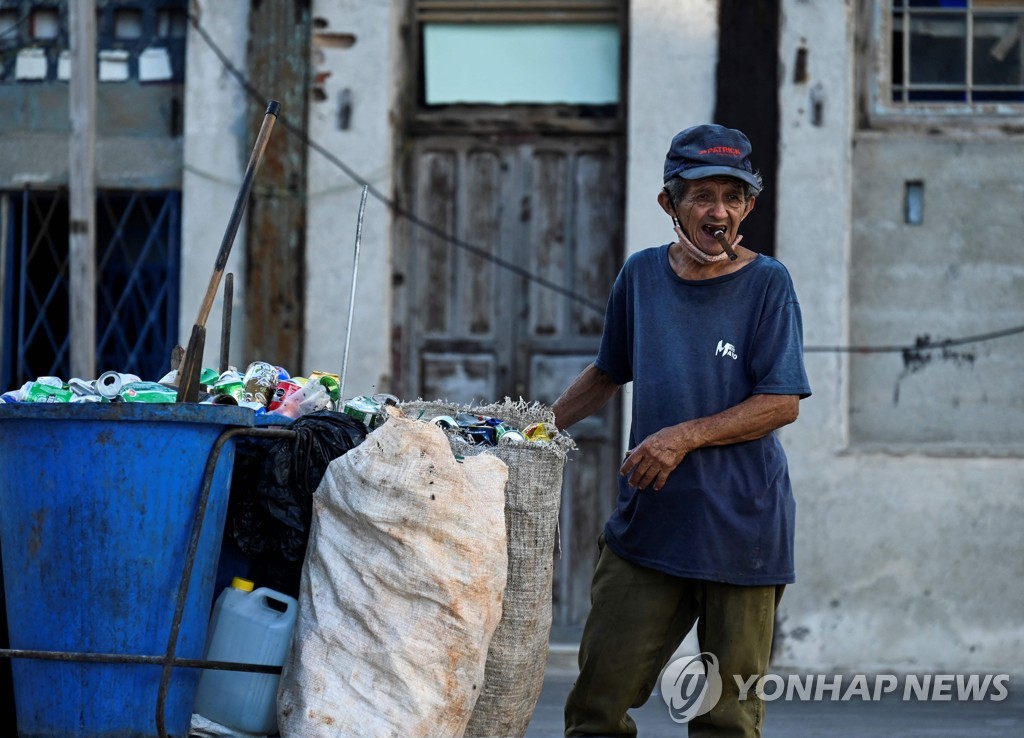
left=0, top=403, right=253, bottom=738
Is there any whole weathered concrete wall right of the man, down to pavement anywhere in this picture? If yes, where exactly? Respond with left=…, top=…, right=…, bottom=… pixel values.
left=776, top=0, right=1024, bottom=671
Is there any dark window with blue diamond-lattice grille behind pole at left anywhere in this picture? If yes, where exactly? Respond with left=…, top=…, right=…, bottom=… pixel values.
left=0, top=188, right=180, bottom=390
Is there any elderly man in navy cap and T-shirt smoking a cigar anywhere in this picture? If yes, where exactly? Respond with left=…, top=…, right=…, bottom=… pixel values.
left=554, top=125, right=811, bottom=736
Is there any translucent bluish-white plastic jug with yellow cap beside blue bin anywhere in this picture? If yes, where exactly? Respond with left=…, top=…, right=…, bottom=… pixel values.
left=194, top=577, right=298, bottom=735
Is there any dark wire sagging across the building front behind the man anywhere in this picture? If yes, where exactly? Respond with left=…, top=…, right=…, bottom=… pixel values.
left=188, top=13, right=1024, bottom=354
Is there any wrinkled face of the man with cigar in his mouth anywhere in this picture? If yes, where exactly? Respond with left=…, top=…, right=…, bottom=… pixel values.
left=676, top=177, right=754, bottom=255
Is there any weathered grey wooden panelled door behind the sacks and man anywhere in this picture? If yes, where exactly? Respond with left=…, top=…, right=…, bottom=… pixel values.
left=393, top=133, right=624, bottom=637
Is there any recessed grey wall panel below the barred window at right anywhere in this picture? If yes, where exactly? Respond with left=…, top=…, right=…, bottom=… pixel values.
left=850, top=137, right=1024, bottom=448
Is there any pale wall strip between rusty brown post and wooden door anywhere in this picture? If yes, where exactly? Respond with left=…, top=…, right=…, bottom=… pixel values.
left=305, top=0, right=395, bottom=397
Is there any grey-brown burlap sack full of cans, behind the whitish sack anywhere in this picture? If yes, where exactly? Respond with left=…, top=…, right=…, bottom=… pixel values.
left=401, top=398, right=575, bottom=738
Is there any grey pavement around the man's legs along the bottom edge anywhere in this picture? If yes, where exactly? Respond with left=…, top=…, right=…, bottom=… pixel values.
left=526, top=645, right=1024, bottom=738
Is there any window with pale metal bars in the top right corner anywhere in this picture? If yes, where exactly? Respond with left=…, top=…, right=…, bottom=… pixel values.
left=890, top=0, right=1024, bottom=105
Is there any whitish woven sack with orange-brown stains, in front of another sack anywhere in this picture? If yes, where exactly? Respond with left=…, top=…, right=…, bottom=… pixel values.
left=278, top=409, right=508, bottom=738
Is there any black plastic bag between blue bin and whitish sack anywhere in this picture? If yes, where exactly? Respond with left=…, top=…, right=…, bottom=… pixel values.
left=226, top=410, right=367, bottom=597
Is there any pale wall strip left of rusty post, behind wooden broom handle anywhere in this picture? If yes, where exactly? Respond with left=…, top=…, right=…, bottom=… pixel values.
left=178, top=0, right=250, bottom=372
